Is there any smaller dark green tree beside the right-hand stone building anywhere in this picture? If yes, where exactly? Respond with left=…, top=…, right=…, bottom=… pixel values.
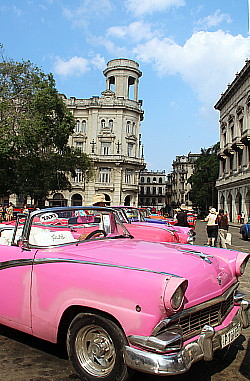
left=188, top=143, right=220, bottom=210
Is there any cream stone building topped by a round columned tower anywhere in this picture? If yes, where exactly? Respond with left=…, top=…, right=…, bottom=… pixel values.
left=50, top=59, right=145, bottom=206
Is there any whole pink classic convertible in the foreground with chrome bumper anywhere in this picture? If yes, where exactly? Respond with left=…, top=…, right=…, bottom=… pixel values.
left=0, top=207, right=250, bottom=381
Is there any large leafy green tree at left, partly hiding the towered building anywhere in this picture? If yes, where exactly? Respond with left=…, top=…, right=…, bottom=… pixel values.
left=0, top=46, right=93, bottom=200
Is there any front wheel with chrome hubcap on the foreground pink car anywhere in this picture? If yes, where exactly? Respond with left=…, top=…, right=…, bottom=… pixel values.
left=67, top=313, right=129, bottom=381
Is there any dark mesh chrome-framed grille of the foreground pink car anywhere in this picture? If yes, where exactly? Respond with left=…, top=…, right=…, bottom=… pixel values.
left=178, top=293, right=234, bottom=340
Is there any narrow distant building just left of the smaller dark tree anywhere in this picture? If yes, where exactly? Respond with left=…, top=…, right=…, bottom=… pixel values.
left=170, top=152, right=200, bottom=207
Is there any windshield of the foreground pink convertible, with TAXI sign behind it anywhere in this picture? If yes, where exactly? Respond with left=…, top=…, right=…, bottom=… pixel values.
left=10, top=207, right=131, bottom=247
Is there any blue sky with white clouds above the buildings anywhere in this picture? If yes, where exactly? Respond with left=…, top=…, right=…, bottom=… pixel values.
left=0, top=0, right=250, bottom=173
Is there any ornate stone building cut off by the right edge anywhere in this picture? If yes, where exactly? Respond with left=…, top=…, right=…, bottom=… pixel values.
left=214, top=60, right=250, bottom=222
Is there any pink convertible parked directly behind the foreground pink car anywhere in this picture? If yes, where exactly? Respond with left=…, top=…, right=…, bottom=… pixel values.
left=112, top=206, right=196, bottom=244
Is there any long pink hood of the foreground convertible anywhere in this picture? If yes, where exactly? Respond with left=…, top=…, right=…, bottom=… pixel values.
left=43, top=238, right=237, bottom=308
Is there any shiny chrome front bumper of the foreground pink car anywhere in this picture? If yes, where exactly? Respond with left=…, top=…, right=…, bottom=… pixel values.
left=124, top=300, right=250, bottom=376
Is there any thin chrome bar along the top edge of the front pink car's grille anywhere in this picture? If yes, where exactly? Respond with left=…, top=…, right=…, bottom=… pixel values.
left=152, top=282, right=239, bottom=336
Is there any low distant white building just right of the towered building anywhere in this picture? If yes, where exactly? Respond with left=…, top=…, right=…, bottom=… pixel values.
left=139, top=170, right=166, bottom=211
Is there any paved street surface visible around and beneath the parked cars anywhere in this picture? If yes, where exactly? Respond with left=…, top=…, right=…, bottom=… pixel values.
left=0, top=222, right=250, bottom=381
